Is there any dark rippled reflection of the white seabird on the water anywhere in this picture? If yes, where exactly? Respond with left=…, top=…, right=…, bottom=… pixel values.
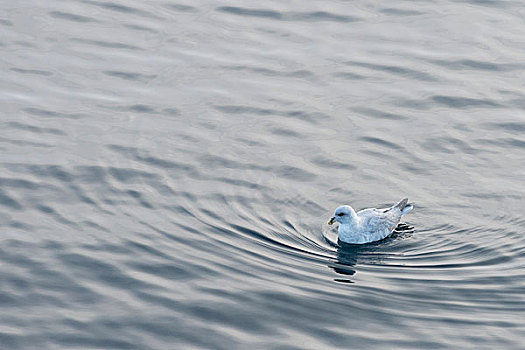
left=328, top=223, right=414, bottom=283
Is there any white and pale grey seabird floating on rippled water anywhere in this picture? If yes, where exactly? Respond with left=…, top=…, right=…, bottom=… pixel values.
left=328, top=198, right=414, bottom=244
